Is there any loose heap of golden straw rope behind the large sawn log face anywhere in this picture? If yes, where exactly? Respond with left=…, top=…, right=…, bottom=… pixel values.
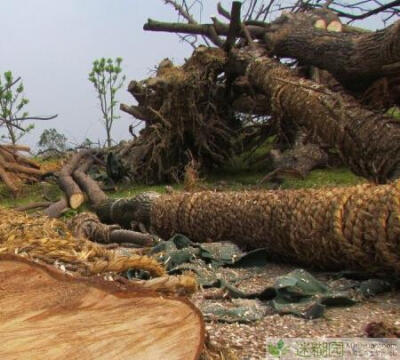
left=0, top=208, right=165, bottom=277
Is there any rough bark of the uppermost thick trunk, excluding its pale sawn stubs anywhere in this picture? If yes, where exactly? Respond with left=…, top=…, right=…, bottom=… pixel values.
left=265, top=11, right=400, bottom=90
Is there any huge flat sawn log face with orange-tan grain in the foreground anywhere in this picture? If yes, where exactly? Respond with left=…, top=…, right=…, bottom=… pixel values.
left=0, top=256, right=204, bottom=360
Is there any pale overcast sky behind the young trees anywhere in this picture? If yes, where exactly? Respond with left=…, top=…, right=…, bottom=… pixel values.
left=0, top=0, right=394, bottom=146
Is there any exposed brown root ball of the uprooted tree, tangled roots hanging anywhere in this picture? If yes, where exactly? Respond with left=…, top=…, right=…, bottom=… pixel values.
left=117, top=47, right=237, bottom=182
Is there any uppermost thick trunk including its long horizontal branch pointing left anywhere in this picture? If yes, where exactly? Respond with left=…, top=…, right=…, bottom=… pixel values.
left=144, top=10, right=400, bottom=90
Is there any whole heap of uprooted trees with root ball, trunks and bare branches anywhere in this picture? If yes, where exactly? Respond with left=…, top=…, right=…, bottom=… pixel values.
left=116, top=1, right=400, bottom=183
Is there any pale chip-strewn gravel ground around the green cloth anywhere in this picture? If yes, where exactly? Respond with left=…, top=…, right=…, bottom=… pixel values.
left=192, top=264, right=400, bottom=360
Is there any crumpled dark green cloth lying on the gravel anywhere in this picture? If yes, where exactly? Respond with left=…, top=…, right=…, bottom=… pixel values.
left=146, top=234, right=393, bottom=322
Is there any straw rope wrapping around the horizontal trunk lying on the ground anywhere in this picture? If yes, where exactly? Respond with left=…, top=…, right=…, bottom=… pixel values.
left=151, top=183, right=400, bottom=274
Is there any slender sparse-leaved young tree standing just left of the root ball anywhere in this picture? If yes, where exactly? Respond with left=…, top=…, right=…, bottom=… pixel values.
left=89, top=57, right=126, bottom=147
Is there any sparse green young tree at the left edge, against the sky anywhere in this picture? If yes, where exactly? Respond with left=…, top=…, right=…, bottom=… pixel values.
left=0, top=71, right=35, bottom=144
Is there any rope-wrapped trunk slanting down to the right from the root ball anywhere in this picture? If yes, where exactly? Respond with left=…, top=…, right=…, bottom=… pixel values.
left=231, top=50, right=400, bottom=183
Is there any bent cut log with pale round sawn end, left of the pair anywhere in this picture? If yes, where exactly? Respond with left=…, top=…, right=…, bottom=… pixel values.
left=58, top=150, right=90, bottom=209
